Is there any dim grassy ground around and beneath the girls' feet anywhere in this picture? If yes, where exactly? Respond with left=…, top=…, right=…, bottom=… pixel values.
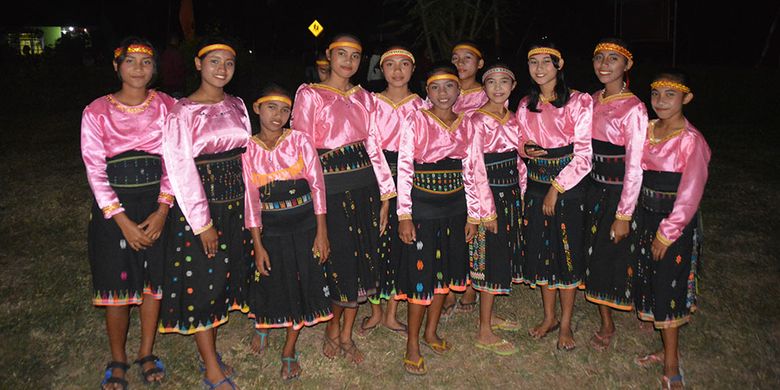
left=0, top=66, right=780, bottom=389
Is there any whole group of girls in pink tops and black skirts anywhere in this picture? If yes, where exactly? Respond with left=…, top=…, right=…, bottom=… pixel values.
left=81, top=34, right=710, bottom=389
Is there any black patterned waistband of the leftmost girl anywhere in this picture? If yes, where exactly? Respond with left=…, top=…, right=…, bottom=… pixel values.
left=106, top=150, right=162, bottom=192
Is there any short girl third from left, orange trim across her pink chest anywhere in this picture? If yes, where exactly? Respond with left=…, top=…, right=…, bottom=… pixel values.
left=241, top=86, right=333, bottom=379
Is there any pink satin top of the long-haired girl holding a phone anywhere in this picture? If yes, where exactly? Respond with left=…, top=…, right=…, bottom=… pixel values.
left=515, top=90, right=593, bottom=192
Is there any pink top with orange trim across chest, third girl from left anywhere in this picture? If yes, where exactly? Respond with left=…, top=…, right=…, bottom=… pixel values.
left=241, top=129, right=327, bottom=228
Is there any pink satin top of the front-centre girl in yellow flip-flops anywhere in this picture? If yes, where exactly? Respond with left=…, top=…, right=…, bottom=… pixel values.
left=397, top=110, right=496, bottom=223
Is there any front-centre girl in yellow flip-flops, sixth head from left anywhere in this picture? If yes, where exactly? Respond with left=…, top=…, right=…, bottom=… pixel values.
left=396, top=65, right=495, bottom=375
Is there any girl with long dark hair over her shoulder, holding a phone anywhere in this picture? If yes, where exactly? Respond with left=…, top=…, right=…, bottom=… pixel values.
left=517, top=42, right=593, bottom=351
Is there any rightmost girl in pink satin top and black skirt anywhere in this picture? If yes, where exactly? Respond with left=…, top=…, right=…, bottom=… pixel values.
left=635, top=69, right=711, bottom=388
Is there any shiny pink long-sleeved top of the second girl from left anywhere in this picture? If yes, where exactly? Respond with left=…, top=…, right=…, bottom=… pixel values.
left=162, top=94, right=252, bottom=235
